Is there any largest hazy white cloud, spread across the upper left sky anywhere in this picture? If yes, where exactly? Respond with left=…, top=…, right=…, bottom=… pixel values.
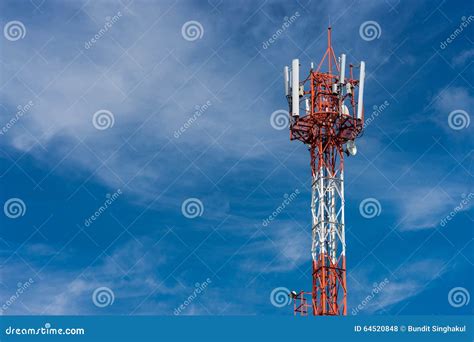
left=2, top=2, right=388, bottom=203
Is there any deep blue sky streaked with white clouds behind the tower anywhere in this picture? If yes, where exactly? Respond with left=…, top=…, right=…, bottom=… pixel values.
left=0, top=0, right=474, bottom=315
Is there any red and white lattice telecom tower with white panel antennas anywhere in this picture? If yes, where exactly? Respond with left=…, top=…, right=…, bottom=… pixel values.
left=284, top=28, right=365, bottom=315
